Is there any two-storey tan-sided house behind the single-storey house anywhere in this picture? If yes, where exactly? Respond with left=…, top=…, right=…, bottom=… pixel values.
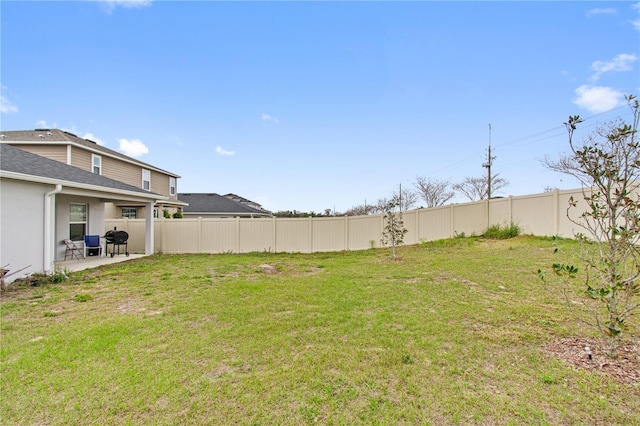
left=0, top=129, right=184, bottom=219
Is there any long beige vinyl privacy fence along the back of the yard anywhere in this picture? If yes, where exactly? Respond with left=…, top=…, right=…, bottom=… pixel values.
left=105, top=189, right=584, bottom=253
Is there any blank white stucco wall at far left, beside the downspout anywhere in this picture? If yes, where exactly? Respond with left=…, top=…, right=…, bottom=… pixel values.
left=0, top=179, right=48, bottom=282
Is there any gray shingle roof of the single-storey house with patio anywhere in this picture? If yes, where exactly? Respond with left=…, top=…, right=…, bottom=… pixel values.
left=0, top=143, right=166, bottom=199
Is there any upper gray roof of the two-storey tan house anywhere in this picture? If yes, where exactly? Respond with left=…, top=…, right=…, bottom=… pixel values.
left=0, top=129, right=180, bottom=178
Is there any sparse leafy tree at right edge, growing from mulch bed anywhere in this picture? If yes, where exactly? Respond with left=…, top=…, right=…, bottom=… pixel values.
left=545, top=96, right=640, bottom=358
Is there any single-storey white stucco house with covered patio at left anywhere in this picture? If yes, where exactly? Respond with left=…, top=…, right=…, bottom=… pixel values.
left=0, top=144, right=167, bottom=281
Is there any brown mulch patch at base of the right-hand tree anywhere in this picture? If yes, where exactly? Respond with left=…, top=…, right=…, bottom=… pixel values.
left=543, top=338, right=640, bottom=385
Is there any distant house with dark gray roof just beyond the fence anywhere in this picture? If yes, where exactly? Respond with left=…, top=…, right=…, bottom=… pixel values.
left=178, top=193, right=272, bottom=218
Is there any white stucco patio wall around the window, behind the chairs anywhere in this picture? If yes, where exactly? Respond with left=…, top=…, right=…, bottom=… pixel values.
left=55, top=194, right=104, bottom=260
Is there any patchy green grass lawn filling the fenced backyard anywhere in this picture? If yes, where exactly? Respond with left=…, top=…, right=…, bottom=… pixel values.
left=0, top=236, right=640, bottom=425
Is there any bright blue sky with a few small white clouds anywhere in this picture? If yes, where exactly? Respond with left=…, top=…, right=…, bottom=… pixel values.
left=0, top=0, right=640, bottom=212
